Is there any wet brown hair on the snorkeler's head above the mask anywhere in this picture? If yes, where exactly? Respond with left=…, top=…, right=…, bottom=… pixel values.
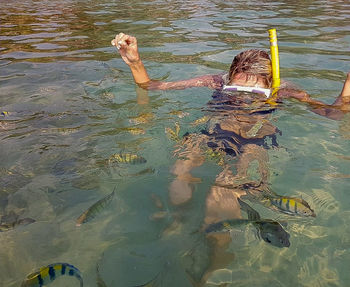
left=229, top=49, right=272, bottom=87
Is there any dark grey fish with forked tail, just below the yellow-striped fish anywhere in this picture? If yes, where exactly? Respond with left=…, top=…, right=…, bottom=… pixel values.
left=205, top=198, right=290, bottom=248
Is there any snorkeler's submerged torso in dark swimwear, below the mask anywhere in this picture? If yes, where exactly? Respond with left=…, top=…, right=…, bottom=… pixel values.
left=202, top=90, right=281, bottom=156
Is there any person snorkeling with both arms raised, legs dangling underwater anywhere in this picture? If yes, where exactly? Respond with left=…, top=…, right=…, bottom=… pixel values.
left=112, top=33, right=350, bottom=282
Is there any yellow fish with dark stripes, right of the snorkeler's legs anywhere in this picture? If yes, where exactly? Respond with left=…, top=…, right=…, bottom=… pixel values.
left=268, top=196, right=316, bottom=217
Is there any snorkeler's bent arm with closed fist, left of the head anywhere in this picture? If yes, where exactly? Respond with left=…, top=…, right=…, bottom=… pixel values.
left=111, top=33, right=223, bottom=90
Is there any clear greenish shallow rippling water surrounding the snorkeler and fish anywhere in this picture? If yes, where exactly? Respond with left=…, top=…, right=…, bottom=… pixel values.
left=0, top=1, right=350, bottom=286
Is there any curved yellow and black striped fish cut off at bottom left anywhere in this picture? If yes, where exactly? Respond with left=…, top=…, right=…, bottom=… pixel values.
left=21, top=263, right=83, bottom=287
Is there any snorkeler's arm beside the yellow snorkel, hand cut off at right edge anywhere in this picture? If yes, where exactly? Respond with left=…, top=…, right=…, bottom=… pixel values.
left=278, top=73, right=350, bottom=120
